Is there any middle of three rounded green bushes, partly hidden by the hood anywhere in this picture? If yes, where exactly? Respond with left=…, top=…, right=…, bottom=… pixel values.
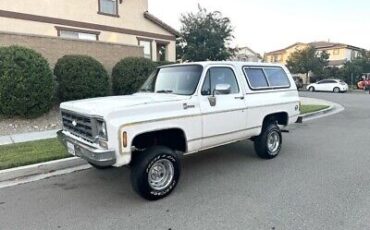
left=54, top=55, right=109, bottom=101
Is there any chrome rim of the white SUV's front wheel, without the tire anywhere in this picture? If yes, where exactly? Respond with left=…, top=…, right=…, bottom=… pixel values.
left=148, top=159, right=175, bottom=191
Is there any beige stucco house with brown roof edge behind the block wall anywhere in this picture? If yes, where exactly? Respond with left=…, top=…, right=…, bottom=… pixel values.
left=0, top=0, right=178, bottom=61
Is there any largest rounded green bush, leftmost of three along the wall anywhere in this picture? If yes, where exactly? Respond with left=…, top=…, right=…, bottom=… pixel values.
left=0, top=46, right=54, bottom=118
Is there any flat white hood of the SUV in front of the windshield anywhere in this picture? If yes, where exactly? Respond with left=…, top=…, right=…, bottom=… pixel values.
left=60, top=93, right=189, bottom=117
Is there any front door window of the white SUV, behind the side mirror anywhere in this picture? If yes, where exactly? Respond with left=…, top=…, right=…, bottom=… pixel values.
left=202, top=67, right=239, bottom=95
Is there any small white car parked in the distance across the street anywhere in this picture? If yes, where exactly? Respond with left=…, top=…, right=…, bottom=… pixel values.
left=307, top=79, right=348, bottom=93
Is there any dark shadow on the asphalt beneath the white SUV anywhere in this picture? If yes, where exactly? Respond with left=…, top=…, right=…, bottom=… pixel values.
left=41, top=141, right=263, bottom=203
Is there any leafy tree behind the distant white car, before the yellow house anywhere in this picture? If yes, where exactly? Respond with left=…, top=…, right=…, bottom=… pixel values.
left=287, top=46, right=329, bottom=81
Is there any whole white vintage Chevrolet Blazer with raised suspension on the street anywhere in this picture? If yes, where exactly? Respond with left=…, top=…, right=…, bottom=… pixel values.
left=58, top=62, right=299, bottom=200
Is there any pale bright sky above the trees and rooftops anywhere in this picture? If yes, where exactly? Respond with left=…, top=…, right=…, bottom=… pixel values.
left=149, top=0, right=370, bottom=54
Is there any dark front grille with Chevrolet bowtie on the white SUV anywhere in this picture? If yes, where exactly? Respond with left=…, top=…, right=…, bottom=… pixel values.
left=62, top=111, right=94, bottom=142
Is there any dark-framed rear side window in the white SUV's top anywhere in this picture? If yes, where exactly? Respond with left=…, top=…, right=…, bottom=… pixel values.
left=243, top=67, right=290, bottom=90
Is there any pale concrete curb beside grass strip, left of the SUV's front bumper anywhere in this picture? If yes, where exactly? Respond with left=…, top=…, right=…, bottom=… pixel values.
left=0, top=157, right=89, bottom=183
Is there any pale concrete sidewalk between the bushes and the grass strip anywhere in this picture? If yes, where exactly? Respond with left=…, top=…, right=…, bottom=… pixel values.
left=0, top=129, right=58, bottom=145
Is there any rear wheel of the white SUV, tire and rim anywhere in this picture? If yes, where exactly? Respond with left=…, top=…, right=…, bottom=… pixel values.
left=254, top=123, right=282, bottom=159
